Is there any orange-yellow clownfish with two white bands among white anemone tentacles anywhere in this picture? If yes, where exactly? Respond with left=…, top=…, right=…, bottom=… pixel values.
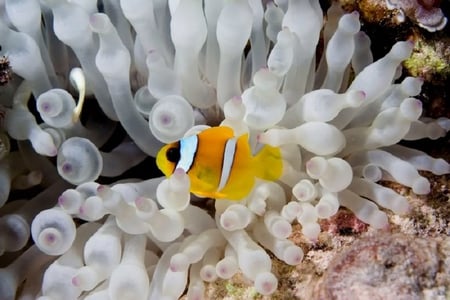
left=156, top=126, right=283, bottom=200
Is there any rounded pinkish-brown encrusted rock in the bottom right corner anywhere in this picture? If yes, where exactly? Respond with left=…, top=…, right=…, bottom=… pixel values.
left=314, top=232, right=450, bottom=300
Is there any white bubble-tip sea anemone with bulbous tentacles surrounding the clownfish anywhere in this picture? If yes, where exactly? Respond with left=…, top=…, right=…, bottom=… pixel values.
left=0, top=0, right=450, bottom=300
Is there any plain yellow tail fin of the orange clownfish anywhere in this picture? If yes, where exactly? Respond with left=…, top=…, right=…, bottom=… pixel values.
left=253, top=145, right=283, bottom=181
